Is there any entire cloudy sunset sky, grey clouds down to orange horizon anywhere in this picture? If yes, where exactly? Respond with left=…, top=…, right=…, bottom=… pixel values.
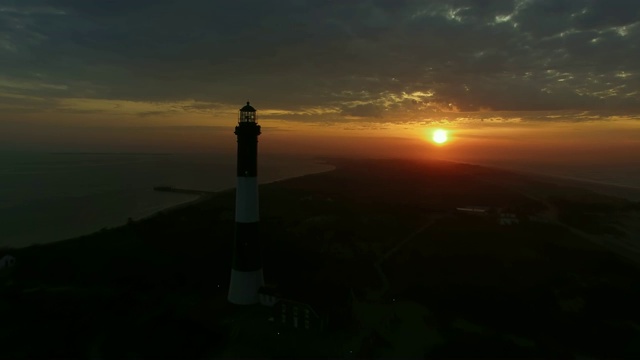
left=0, top=0, right=640, bottom=161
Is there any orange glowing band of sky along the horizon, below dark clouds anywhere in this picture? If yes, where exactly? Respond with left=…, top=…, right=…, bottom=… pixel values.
left=0, top=99, right=640, bottom=166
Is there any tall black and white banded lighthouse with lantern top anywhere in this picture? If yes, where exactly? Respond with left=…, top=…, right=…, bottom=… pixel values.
left=227, top=101, right=264, bottom=305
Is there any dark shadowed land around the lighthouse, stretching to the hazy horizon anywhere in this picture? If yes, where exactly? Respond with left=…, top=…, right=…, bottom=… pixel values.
left=0, top=159, right=640, bottom=359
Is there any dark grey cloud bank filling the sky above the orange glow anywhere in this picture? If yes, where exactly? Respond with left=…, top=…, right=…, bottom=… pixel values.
left=0, top=0, right=640, bottom=117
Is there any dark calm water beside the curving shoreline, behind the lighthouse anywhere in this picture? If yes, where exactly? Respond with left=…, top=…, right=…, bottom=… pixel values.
left=0, top=153, right=332, bottom=247
